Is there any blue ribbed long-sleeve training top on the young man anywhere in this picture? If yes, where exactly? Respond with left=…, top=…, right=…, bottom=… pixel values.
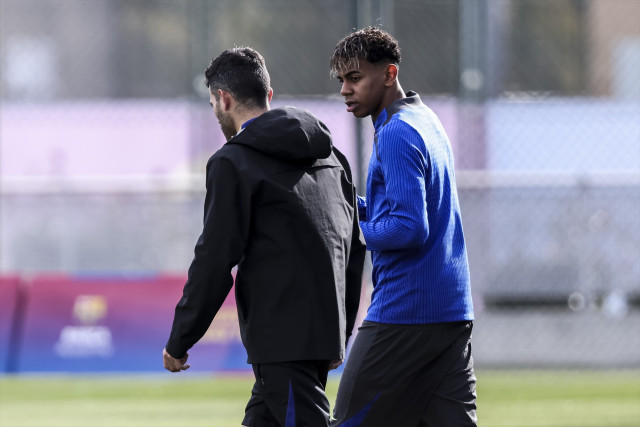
left=358, top=92, right=473, bottom=324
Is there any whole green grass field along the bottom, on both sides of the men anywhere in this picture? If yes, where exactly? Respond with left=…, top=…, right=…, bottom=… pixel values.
left=0, top=371, right=640, bottom=427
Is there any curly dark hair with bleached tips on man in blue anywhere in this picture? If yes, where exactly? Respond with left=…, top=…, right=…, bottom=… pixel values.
left=329, top=27, right=400, bottom=75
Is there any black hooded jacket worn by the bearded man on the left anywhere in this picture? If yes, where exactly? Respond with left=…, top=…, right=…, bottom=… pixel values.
left=166, top=107, right=366, bottom=363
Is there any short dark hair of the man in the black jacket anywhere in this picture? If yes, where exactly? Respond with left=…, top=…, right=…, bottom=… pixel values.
left=204, top=47, right=271, bottom=108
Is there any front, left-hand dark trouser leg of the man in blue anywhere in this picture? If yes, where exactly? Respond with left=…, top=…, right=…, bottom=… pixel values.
left=332, top=322, right=475, bottom=427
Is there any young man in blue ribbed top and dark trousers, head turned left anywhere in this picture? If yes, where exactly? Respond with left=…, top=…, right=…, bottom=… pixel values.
left=330, top=27, right=477, bottom=427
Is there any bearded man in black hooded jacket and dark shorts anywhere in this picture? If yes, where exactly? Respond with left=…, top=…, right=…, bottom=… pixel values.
left=163, top=48, right=366, bottom=427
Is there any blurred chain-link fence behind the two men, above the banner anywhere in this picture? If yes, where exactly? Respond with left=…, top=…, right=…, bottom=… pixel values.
left=0, top=0, right=640, bottom=367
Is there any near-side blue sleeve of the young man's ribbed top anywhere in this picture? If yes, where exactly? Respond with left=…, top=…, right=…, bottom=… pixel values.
left=360, top=120, right=429, bottom=250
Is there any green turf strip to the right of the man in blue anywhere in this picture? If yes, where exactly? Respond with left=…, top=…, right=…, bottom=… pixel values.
left=477, top=371, right=640, bottom=427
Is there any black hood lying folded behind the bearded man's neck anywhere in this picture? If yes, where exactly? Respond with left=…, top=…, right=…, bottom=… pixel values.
left=227, top=107, right=332, bottom=163
